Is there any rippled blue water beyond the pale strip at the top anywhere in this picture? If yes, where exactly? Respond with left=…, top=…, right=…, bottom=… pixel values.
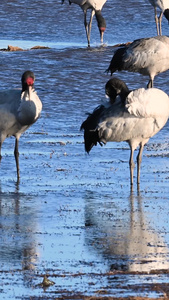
left=0, top=0, right=168, bottom=48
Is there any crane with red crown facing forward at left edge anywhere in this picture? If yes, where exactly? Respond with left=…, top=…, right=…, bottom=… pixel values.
left=0, top=71, right=42, bottom=181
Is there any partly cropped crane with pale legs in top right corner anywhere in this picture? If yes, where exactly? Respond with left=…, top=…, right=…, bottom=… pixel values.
left=149, top=0, right=169, bottom=35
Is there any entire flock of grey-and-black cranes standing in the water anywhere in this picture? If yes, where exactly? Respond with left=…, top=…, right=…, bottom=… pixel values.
left=0, top=0, right=169, bottom=186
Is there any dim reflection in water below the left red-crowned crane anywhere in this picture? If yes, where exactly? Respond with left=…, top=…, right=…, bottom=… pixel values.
left=0, top=184, right=38, bottom=271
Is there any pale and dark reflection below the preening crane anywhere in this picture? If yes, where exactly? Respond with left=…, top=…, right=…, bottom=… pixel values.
left=85, top=193, right=169, bottom=272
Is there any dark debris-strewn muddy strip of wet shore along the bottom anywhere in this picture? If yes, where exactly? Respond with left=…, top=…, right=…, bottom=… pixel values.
left=0, top=256, right=169, bottom=300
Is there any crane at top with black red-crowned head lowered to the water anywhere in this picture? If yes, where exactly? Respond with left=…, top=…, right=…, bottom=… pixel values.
left=62, top=0, right=107, bottom=47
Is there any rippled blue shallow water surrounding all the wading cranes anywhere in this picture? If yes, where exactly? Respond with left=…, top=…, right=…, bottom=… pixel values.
left=0, top=0, right=169, bottom=299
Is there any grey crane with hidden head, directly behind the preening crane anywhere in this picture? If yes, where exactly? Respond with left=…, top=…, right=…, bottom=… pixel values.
left=107, top=36, right=169, bottom=88
